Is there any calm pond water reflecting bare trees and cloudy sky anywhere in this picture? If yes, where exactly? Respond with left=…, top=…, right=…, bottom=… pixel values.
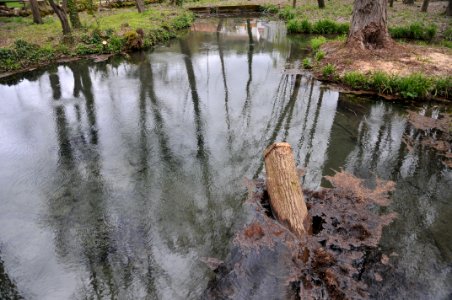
left=0, top=18, right=452, bottom=299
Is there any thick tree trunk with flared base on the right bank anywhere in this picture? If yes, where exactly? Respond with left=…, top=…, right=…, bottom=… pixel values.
left=347, top=0, right=393, bottom=49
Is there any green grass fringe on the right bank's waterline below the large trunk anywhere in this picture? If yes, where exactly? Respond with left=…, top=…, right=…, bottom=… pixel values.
left=296, top=36, right=452, bottom=100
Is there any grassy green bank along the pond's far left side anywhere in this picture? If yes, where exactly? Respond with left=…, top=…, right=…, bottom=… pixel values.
left=0, top=5, right=194, bottom=73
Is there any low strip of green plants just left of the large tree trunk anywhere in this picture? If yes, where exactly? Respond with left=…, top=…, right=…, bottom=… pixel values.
left=287, top=19, right=349, bottom=34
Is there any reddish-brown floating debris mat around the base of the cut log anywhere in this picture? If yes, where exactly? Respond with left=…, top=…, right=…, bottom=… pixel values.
left=203, top=171, right=395, bottom=299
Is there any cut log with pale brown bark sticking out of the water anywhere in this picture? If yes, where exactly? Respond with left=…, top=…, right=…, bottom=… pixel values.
left=264, top=143, right=310, bottom=237
